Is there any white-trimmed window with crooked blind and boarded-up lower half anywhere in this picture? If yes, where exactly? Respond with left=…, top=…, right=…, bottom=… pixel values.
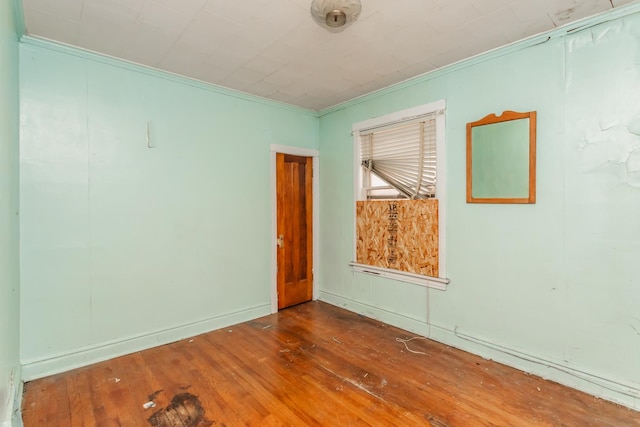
left=351, top=101, right=448, bottom=289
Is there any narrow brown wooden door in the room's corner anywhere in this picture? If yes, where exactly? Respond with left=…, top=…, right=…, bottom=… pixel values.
left=276, top=153, right=313, bottom=309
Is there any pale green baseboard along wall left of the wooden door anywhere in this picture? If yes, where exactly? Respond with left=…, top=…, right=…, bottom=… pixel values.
left=22, top=304, right=271, bottom=381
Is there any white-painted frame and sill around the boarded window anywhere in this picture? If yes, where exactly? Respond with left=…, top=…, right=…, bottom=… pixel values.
left=349, top=100, right=449, bottom=290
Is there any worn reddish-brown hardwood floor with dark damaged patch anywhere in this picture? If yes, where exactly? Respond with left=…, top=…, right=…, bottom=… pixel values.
left=22, top=302, right=640, bottom=427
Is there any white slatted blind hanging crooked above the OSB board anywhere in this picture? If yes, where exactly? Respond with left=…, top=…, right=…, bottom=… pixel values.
left=360, top=112, right=437, bottom=199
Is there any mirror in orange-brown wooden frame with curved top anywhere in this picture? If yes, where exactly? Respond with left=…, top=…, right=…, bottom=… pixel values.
left=467, top=111, right=536, bottom=203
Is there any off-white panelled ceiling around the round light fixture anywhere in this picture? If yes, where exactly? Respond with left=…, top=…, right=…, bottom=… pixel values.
left=23, top=0, right=640, bottom=110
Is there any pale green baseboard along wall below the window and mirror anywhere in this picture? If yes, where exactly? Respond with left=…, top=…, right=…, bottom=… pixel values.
left=320, top=290, right=640, bottom=410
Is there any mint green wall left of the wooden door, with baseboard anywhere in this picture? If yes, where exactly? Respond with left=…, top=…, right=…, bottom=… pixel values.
left=20, top=38, right=319, bottom=378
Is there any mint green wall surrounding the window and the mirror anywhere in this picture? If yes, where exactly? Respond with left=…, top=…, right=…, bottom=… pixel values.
left=320, top=7, right=640, bottom=408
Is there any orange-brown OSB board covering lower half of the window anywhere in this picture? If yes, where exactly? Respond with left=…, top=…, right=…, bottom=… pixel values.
left=356, top=199, right=438, bottom=277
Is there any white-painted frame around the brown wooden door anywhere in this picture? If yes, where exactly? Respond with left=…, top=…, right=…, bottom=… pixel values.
left=269, top=144, right=320, bottom=313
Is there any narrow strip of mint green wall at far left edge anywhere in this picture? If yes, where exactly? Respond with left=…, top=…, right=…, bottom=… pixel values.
left=0, top=0, right=20, bottom=425
